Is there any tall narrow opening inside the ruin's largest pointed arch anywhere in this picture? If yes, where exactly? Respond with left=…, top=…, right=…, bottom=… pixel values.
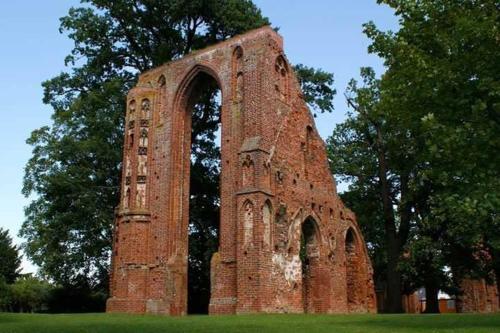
left=187, top=72, right=221, bottom=314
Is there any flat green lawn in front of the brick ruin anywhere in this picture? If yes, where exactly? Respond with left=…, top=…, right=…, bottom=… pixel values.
left=0, top=313, right=500, bottom=333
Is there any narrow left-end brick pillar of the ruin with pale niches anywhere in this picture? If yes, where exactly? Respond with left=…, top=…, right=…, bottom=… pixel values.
left=107, top=89, right=155, bottom=313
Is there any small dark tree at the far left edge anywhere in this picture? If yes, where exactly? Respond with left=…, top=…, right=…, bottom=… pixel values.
left=0, top=228, right=21, bottom=284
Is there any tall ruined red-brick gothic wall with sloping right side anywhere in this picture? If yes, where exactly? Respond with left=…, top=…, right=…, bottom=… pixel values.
left=107, top=27, right=376, bottom=315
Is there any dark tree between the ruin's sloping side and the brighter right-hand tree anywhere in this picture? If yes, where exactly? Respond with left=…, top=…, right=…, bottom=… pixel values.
left=328, top=68, right=414, bottom=312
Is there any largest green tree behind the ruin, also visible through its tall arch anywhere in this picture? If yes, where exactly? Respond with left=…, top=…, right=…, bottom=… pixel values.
left=20, top=0, right=335, bottom=308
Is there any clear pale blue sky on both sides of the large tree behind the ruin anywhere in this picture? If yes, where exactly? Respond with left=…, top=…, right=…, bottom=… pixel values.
left=0, top=0, right=397, bottom=273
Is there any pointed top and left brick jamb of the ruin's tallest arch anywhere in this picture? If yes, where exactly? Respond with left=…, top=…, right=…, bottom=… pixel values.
left=169, top=63, right=224, bottom=313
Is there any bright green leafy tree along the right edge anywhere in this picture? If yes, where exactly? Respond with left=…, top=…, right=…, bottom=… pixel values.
left=365, top=0, right=500, bottom=312
